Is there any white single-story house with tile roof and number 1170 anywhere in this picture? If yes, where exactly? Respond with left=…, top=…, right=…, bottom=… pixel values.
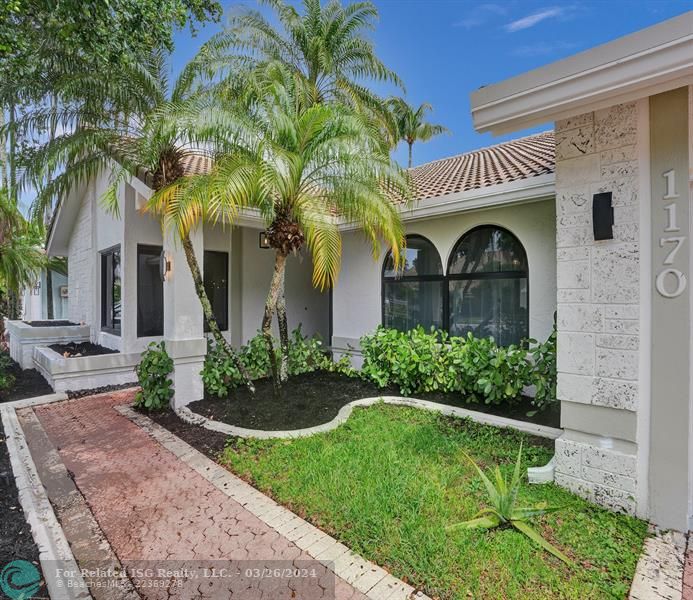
left=5, top=12, right=693, bottom=531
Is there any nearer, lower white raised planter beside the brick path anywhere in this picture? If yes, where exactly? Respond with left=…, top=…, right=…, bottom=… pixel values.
left=33, top=346, right=142, bottom=392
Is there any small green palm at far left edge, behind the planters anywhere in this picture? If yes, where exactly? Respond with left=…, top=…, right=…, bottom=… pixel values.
left=0, top=187, right=46, bottom=324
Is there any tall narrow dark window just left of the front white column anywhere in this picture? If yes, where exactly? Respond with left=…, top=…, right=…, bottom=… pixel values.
left=137, top=246, right=164, bottom=337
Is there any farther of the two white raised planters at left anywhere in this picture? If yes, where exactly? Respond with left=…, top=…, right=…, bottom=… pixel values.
left=6, top=321, right=90, bottom=369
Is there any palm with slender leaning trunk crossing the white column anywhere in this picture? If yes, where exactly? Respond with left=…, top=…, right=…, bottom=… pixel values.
left=14, top=52, right=254, bottom=391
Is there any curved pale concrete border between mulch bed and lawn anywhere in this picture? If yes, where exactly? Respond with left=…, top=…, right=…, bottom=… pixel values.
left=174, top=396, right=563, bottom=440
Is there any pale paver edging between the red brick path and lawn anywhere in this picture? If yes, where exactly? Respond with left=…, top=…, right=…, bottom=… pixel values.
left=121, top=406, right=430, bottom=600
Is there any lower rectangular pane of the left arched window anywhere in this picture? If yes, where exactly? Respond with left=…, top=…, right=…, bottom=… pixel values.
left=383, top=281, right=443, bottom=331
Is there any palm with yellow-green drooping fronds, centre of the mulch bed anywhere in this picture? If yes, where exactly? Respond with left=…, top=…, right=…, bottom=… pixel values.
left=150, top=63, right=409, bottom=391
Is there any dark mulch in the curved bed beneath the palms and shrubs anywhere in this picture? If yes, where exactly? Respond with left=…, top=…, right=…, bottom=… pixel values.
left=189, top=371, right=560, bottom=431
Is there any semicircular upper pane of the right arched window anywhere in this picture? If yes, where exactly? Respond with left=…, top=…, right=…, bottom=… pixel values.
left=448, top=227, right=527, bottom=275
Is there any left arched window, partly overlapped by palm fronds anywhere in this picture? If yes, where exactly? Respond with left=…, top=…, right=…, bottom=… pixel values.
left=382, top=235, right=445, bottom=331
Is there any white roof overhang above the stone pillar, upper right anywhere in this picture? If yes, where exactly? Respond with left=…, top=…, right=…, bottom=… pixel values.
left=471, top=11, right=693, bottom=134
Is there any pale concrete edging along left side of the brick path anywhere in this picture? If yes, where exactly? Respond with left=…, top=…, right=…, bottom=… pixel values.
left=0, top=404, right=91, bottom=600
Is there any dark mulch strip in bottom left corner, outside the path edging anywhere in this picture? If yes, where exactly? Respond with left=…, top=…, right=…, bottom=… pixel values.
left=0, top=434, right=48, bottom=598
